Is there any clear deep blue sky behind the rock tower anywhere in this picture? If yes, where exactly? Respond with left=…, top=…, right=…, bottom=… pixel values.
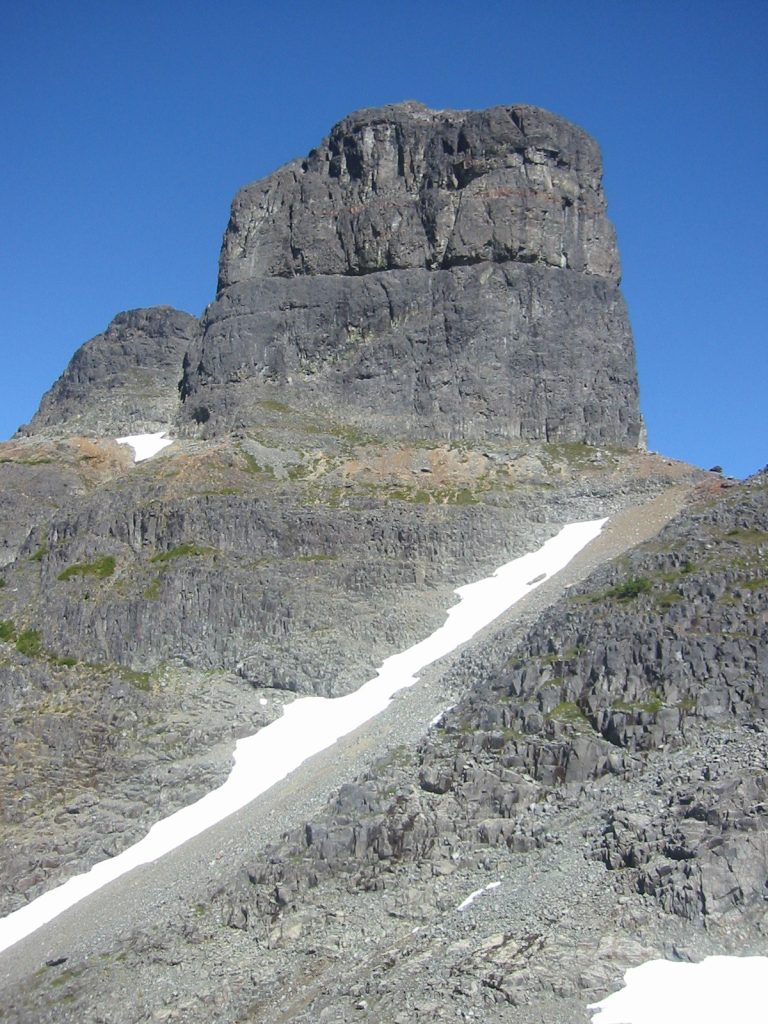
left=0, top=0, right=768, bottom=477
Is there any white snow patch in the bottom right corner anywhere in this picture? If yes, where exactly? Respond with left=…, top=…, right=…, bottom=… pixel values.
left=588, top=956, right=768, bottom=1024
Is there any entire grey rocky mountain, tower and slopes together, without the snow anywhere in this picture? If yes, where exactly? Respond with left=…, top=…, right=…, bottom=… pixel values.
left=0, top=103, right=768, bottom=1024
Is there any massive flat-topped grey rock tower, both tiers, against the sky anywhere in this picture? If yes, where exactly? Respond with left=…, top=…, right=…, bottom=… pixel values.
left=182, top=102, right=642, bottom=446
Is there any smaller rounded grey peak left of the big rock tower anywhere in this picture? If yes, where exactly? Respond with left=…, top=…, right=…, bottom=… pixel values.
left=18, top=306, right=198, bottom=436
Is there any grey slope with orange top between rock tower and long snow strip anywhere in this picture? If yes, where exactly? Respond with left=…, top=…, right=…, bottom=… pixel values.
left=0, top=423, right=688, bottom=929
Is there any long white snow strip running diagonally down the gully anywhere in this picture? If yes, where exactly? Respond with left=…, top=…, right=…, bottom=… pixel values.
left=0, top=516, right=607, bottom=950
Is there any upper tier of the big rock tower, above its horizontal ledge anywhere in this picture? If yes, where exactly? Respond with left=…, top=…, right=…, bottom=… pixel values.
left=219, top=101, right=620, bottom=291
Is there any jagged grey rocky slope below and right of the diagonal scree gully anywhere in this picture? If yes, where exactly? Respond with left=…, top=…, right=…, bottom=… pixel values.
left=5, top=464, right=768, bottom=1024
